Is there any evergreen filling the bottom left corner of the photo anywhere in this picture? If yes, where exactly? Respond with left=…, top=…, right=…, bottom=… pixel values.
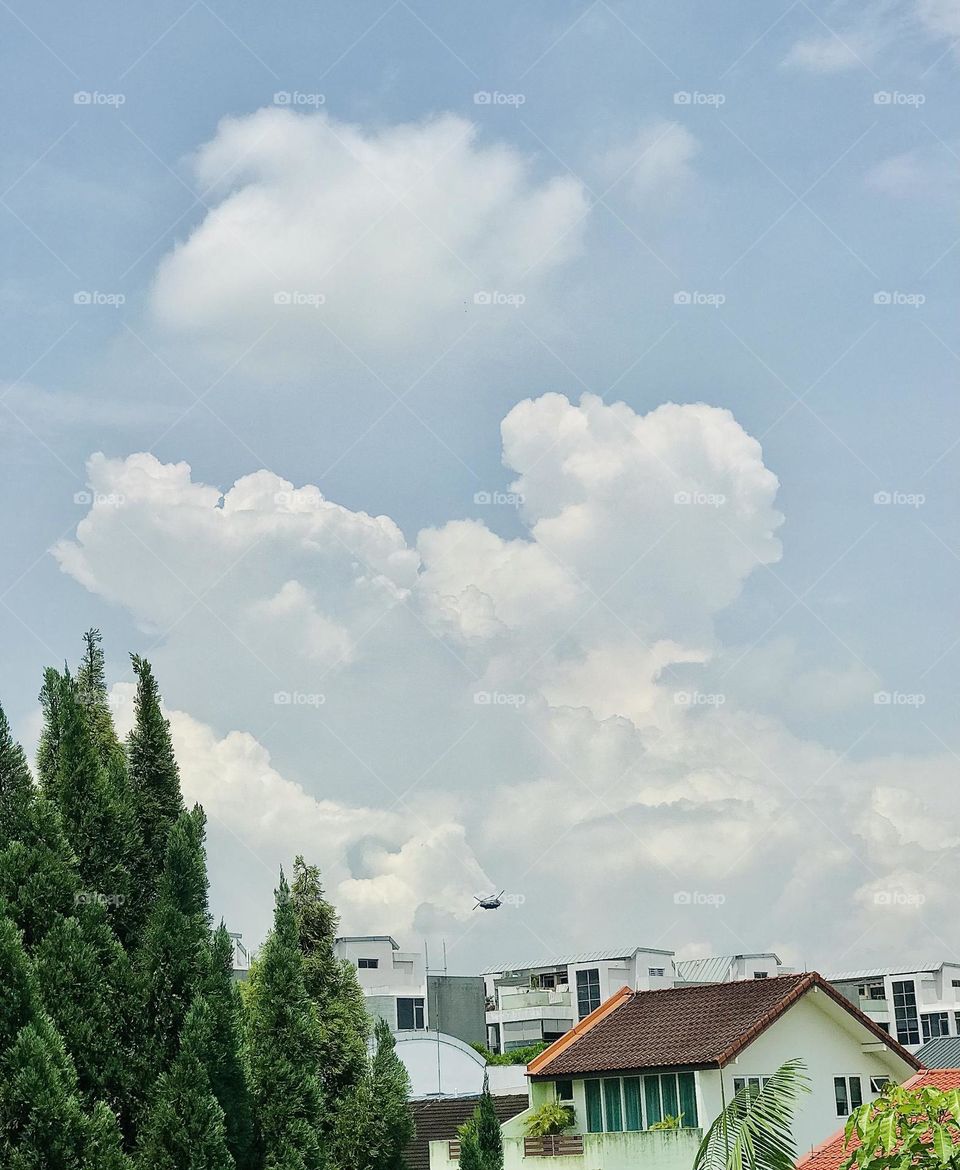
left=0, top=914, right=127, bottom=1170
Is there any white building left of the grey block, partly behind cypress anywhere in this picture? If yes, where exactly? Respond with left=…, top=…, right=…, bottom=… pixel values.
left=333, top=935, right=429, bottom=1032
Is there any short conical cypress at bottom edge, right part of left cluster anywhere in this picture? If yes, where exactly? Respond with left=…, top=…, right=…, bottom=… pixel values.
left=137, top=996, right=235, bottom=1170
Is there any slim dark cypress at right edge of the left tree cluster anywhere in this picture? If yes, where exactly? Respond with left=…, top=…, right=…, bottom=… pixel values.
left=201, top=922, right=256, bottom=1170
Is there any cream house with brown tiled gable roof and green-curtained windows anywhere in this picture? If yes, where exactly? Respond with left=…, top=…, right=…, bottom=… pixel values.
left=430, top=972, right=919, bottom=1170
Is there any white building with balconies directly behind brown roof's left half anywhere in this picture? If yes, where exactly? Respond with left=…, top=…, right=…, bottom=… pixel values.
left=481, top=947, right=674, bottom=1052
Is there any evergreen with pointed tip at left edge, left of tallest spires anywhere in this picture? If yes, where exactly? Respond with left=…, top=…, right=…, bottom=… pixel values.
left=0, top=708, right=77, bottom=948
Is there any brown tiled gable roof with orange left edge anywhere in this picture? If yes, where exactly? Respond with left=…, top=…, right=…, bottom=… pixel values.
left=527, top=971, right=920, bottom=1078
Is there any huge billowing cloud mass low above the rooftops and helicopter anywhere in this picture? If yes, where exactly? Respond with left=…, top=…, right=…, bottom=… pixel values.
left=56, top=394, right=955, bottom=965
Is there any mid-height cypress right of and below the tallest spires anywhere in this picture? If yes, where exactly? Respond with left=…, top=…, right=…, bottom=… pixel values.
left=137, top=805, right=210, bottom=1073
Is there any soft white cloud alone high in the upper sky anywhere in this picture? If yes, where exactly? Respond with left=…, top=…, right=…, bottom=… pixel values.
left=152, top=109, right=587, bottom=349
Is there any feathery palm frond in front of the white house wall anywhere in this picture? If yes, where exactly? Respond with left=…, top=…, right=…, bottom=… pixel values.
left=693, top=1060, right=810, bottom=1170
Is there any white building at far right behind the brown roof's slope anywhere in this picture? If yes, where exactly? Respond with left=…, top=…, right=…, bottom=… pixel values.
left=828, top=962, right=960, bottom=1052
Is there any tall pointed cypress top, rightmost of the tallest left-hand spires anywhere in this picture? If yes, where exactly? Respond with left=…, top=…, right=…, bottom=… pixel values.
left=127, top=654, right=184, bottom=890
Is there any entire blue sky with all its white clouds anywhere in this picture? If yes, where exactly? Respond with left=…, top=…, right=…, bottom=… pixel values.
left=0, top=0, right=960, bottom=969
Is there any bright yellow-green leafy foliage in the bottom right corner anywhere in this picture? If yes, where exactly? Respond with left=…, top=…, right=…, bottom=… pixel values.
left=843, top=1085, right=960, bottom=1170
